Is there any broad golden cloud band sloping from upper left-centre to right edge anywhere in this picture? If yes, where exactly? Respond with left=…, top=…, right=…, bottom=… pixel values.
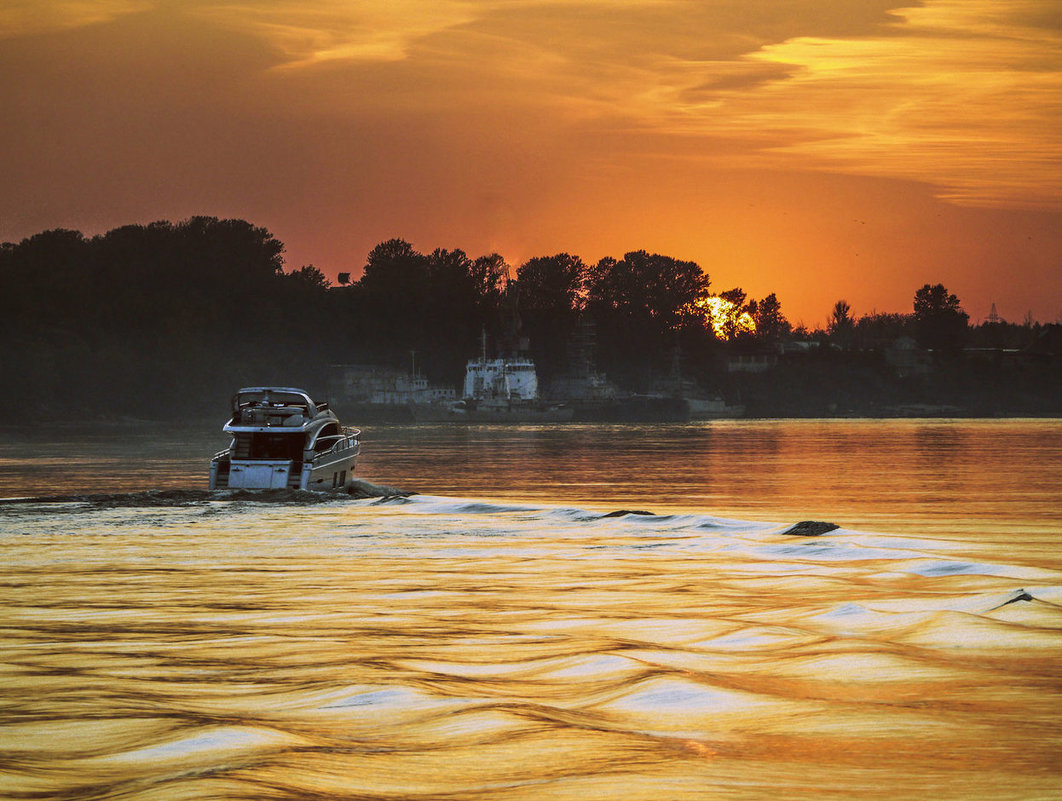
left=198, top=0, right=1062, bottom=205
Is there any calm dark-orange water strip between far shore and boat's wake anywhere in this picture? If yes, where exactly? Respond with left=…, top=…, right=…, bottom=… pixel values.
left=0, top=421, right=1062, bottom=542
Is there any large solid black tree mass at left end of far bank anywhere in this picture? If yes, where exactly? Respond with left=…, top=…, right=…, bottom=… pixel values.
left=0, top=217, right=326, bottom=416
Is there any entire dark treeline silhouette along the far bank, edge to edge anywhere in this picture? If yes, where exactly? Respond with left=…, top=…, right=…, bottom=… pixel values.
left=0, top=217, right=1062, bottom=419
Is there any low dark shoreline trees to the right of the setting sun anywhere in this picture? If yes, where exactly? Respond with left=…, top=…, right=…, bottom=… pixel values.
left=756, top=284, right=1062, bottom=416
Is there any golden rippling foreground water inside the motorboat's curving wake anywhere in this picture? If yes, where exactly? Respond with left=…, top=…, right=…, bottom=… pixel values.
left=0, top=491, right=1062, bottom=800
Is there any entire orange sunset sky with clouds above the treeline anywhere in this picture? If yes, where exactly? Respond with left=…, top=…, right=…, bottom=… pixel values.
left=0, top=0, right=1062, bottom=326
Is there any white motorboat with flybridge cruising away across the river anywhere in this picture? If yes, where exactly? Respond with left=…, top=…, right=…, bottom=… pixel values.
left=210, top=387, right=361, bottom=491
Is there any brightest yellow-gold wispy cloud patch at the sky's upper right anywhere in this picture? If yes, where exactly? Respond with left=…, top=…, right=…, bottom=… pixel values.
left=725, top=0, right=1062, bottom=205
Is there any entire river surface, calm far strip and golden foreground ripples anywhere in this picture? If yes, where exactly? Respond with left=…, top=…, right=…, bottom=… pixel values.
left=0, top=421, right=1062, bottom=801
